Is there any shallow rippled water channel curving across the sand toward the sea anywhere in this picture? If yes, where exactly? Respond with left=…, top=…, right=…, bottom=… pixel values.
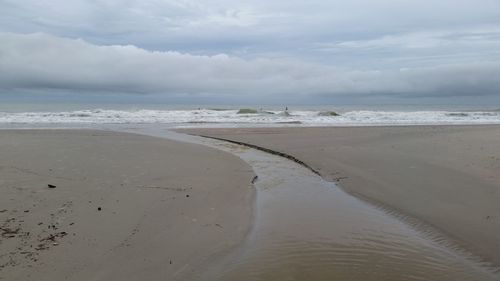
left=114, top=127, right=500, bottom=281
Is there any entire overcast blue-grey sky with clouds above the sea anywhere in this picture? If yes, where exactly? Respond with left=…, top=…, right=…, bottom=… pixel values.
left=0, top=0, right=500, bottom=104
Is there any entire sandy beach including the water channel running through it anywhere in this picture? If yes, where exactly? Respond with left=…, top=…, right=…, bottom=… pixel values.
left=0, top=125, right=500, bottom=281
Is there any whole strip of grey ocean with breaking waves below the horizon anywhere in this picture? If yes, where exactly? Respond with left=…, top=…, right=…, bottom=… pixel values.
left=0, top=103, right=500, bottom=127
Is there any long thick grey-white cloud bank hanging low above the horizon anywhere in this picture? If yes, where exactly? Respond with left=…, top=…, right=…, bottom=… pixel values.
left=0, top=33, right=500, bottom=101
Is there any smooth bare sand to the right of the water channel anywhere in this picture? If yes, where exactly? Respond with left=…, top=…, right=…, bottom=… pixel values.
left=182, top=125, right=500, bottom=265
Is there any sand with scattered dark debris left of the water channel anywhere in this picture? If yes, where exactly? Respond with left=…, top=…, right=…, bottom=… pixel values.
left=0, top=130, right=254, bottom=281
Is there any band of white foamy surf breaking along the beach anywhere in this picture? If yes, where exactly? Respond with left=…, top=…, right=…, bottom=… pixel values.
left=0, top=109, right=500, bottom=126
